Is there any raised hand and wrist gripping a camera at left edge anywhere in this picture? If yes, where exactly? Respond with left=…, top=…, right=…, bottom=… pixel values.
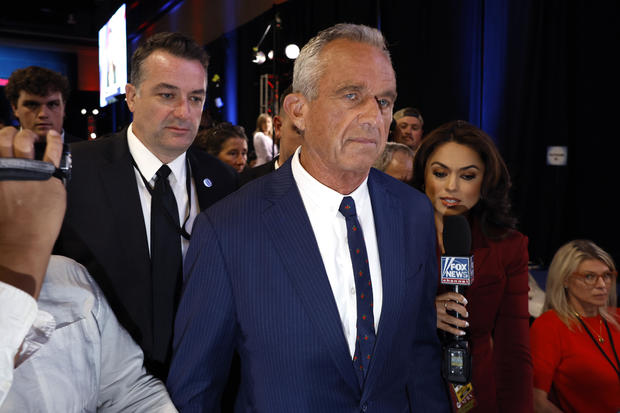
left=0, top=127, right=67, bottom=298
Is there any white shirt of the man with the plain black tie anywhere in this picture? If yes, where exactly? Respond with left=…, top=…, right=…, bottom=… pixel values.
left=127, top=124, right=200, bottom=258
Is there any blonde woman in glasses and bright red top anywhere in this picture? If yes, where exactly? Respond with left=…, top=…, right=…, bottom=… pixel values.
left=531, top=240, right=620, bottom=412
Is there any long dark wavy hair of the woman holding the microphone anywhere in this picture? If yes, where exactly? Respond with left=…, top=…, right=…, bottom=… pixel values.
left=411, top=120, right=517, bottom=238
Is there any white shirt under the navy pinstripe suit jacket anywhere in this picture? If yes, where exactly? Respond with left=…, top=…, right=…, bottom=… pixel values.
left=291, top=148, right=383, bottom=358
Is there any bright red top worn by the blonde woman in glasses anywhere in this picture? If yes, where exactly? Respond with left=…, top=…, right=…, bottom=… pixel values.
left=531, top=309, right=620, bottom=413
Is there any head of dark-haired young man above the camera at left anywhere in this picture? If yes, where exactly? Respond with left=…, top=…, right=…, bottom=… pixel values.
left=5, top=66, right=82, bottom=143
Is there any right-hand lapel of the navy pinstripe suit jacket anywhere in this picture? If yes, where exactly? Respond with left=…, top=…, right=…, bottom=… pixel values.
left=364, top=169, right=407, bottom=394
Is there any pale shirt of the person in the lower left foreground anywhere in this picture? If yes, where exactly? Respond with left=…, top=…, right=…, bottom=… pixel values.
left=0, top=255, right=176, bottom=413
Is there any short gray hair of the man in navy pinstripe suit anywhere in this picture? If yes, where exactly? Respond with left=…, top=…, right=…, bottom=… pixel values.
left=293, top=23, right=392, bottom=100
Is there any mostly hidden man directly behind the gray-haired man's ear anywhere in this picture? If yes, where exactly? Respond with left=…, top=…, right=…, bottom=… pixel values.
left=239, top=86, right=302, bottom=185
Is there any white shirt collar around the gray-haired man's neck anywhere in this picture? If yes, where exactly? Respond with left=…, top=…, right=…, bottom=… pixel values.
left=291, top=146, right=369, bottom=215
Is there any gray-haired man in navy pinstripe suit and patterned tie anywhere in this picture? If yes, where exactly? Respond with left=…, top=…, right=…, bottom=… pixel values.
left=168, top=24, right=449, bottom=413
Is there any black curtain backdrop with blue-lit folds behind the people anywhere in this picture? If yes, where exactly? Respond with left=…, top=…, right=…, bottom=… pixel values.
left=0, top=0, right=620, bottom=265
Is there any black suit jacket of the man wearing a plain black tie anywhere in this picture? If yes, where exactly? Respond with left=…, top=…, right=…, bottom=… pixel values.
left=55, top=129, right=238, bottom=377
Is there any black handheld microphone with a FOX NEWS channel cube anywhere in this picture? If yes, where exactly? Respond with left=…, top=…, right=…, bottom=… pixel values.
left=440, top=215, right=474, bottom=384
